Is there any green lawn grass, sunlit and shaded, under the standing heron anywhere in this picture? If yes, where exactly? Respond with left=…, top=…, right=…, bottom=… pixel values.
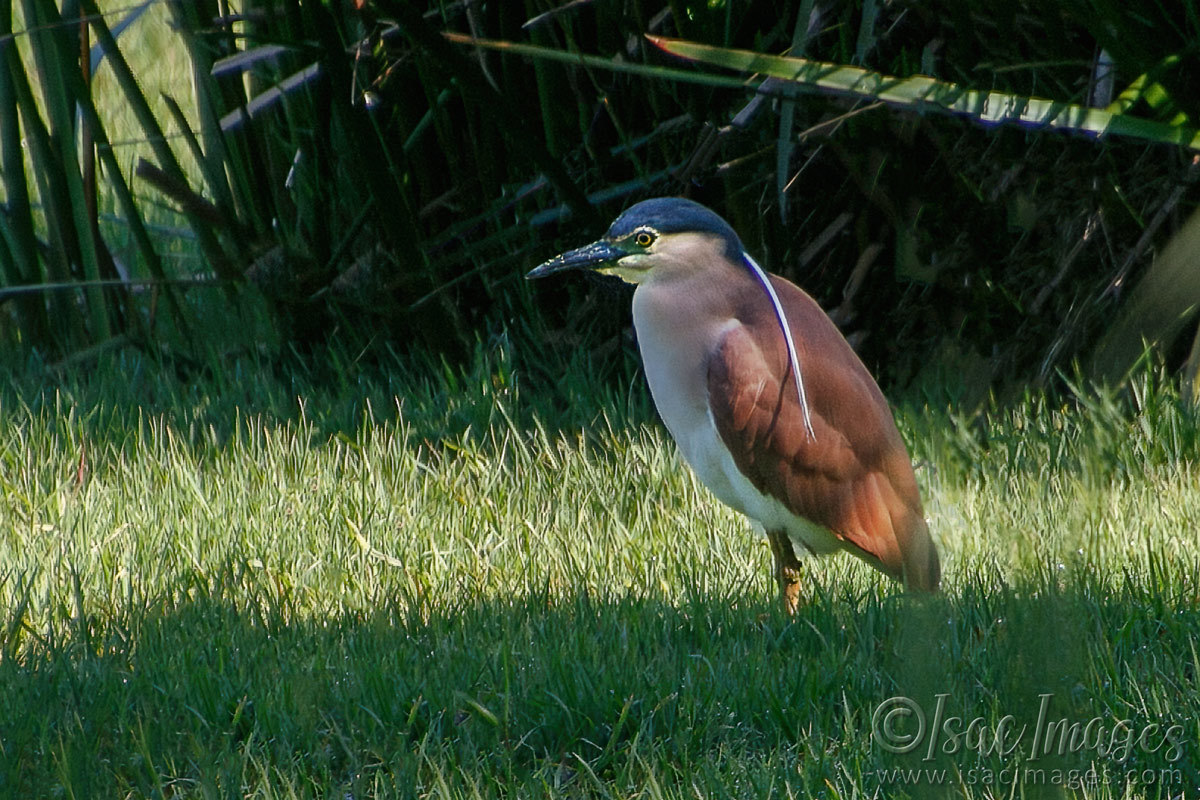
left=0, top=343, right=1200, bottom=798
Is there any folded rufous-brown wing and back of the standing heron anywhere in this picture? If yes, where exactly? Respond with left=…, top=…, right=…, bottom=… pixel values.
left=708, top=278, right=940, bottom=589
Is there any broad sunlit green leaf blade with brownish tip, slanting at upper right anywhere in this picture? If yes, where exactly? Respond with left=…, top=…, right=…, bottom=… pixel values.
left=647, top=36, right=1200, bottom=150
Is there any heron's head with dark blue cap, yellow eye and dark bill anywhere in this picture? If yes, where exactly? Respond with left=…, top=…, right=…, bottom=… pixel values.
left=526, top=197, right=743, bottom=283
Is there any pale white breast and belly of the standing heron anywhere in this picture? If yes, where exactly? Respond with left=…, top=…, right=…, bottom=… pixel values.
left=634, top=289, right=840, bottom=557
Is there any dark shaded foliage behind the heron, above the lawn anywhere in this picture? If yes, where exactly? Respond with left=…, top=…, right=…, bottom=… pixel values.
left=0, top=0, right=1200, bottom=390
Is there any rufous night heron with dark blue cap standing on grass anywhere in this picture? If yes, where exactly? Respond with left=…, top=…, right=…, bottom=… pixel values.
left=526, top=197, right=941, bottom=614
